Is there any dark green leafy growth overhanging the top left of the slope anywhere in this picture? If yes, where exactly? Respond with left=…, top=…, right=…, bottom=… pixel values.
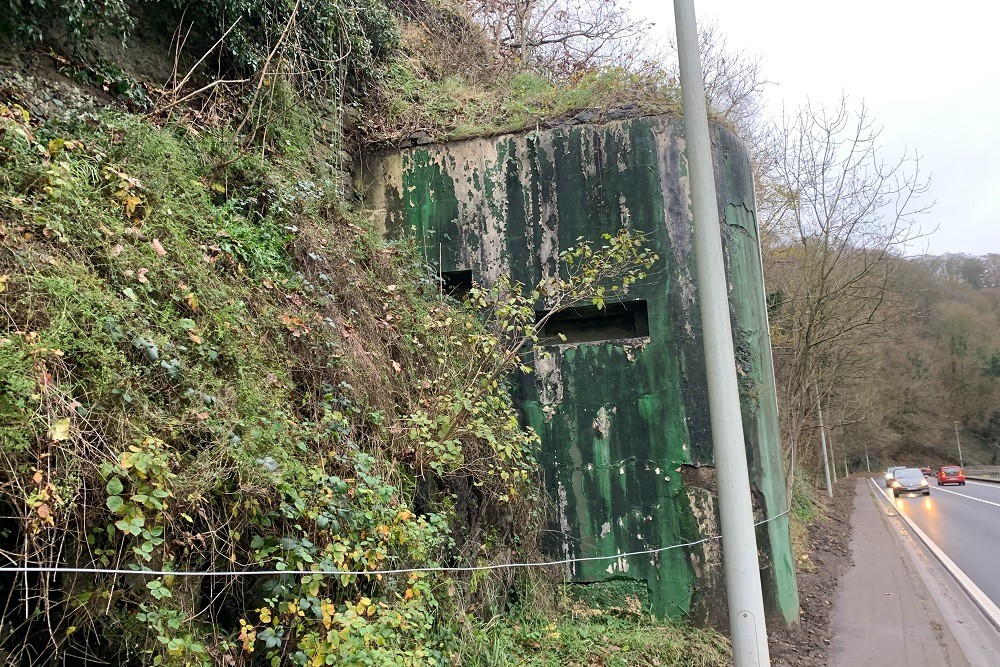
left=0, top=0, right=399, bottom=98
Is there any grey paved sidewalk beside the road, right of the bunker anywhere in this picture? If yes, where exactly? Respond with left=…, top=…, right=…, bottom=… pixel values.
left=829, top=479, right=970, bottom=667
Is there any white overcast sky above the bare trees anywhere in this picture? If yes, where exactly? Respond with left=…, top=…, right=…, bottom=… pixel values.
left=632, top=0, right=1000, bottom=254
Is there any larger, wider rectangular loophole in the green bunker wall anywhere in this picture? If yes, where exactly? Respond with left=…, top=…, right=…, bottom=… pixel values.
left=535, top=299, right=649, bottom=345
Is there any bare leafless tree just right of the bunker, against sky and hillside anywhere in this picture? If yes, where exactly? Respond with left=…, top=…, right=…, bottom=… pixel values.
left=765, top=99, right=930, bottom=496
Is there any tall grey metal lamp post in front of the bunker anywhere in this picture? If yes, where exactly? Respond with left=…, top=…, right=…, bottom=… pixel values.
left=674, top=0, right=771, bottom=667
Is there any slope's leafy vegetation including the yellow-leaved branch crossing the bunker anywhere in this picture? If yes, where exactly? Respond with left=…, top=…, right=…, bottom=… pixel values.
left=0, top=96, right=668, bottom=665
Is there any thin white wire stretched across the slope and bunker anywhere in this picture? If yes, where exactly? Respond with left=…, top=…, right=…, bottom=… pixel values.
left=0, top=507, right=791, bottom=577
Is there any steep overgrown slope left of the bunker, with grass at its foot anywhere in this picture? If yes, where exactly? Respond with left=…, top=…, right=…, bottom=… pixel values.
left=0, top=3, right=727, bottom=665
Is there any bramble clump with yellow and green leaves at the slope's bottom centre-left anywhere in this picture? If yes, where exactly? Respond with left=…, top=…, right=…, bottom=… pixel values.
left=240, top=453, right=447, bottom=665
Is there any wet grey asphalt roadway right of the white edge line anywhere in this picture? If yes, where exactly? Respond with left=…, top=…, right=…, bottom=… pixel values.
left=892, top=477, right=1000, bottom=606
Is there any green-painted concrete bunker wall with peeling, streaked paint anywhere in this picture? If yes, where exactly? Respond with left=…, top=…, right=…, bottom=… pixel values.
left=362, top=116, right=798, bottom=623
